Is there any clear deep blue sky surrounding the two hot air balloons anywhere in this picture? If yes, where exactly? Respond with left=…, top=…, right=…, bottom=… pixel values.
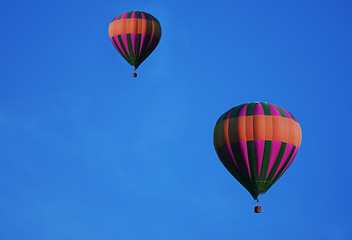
left=0, top=0, right=352, bottom=240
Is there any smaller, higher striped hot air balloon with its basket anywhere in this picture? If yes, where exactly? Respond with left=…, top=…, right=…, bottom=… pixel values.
left=109, top=11, right=161, bottom=77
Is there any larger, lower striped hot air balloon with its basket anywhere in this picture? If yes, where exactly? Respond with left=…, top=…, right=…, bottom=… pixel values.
left=214, top=102, right=302, bottom=213
